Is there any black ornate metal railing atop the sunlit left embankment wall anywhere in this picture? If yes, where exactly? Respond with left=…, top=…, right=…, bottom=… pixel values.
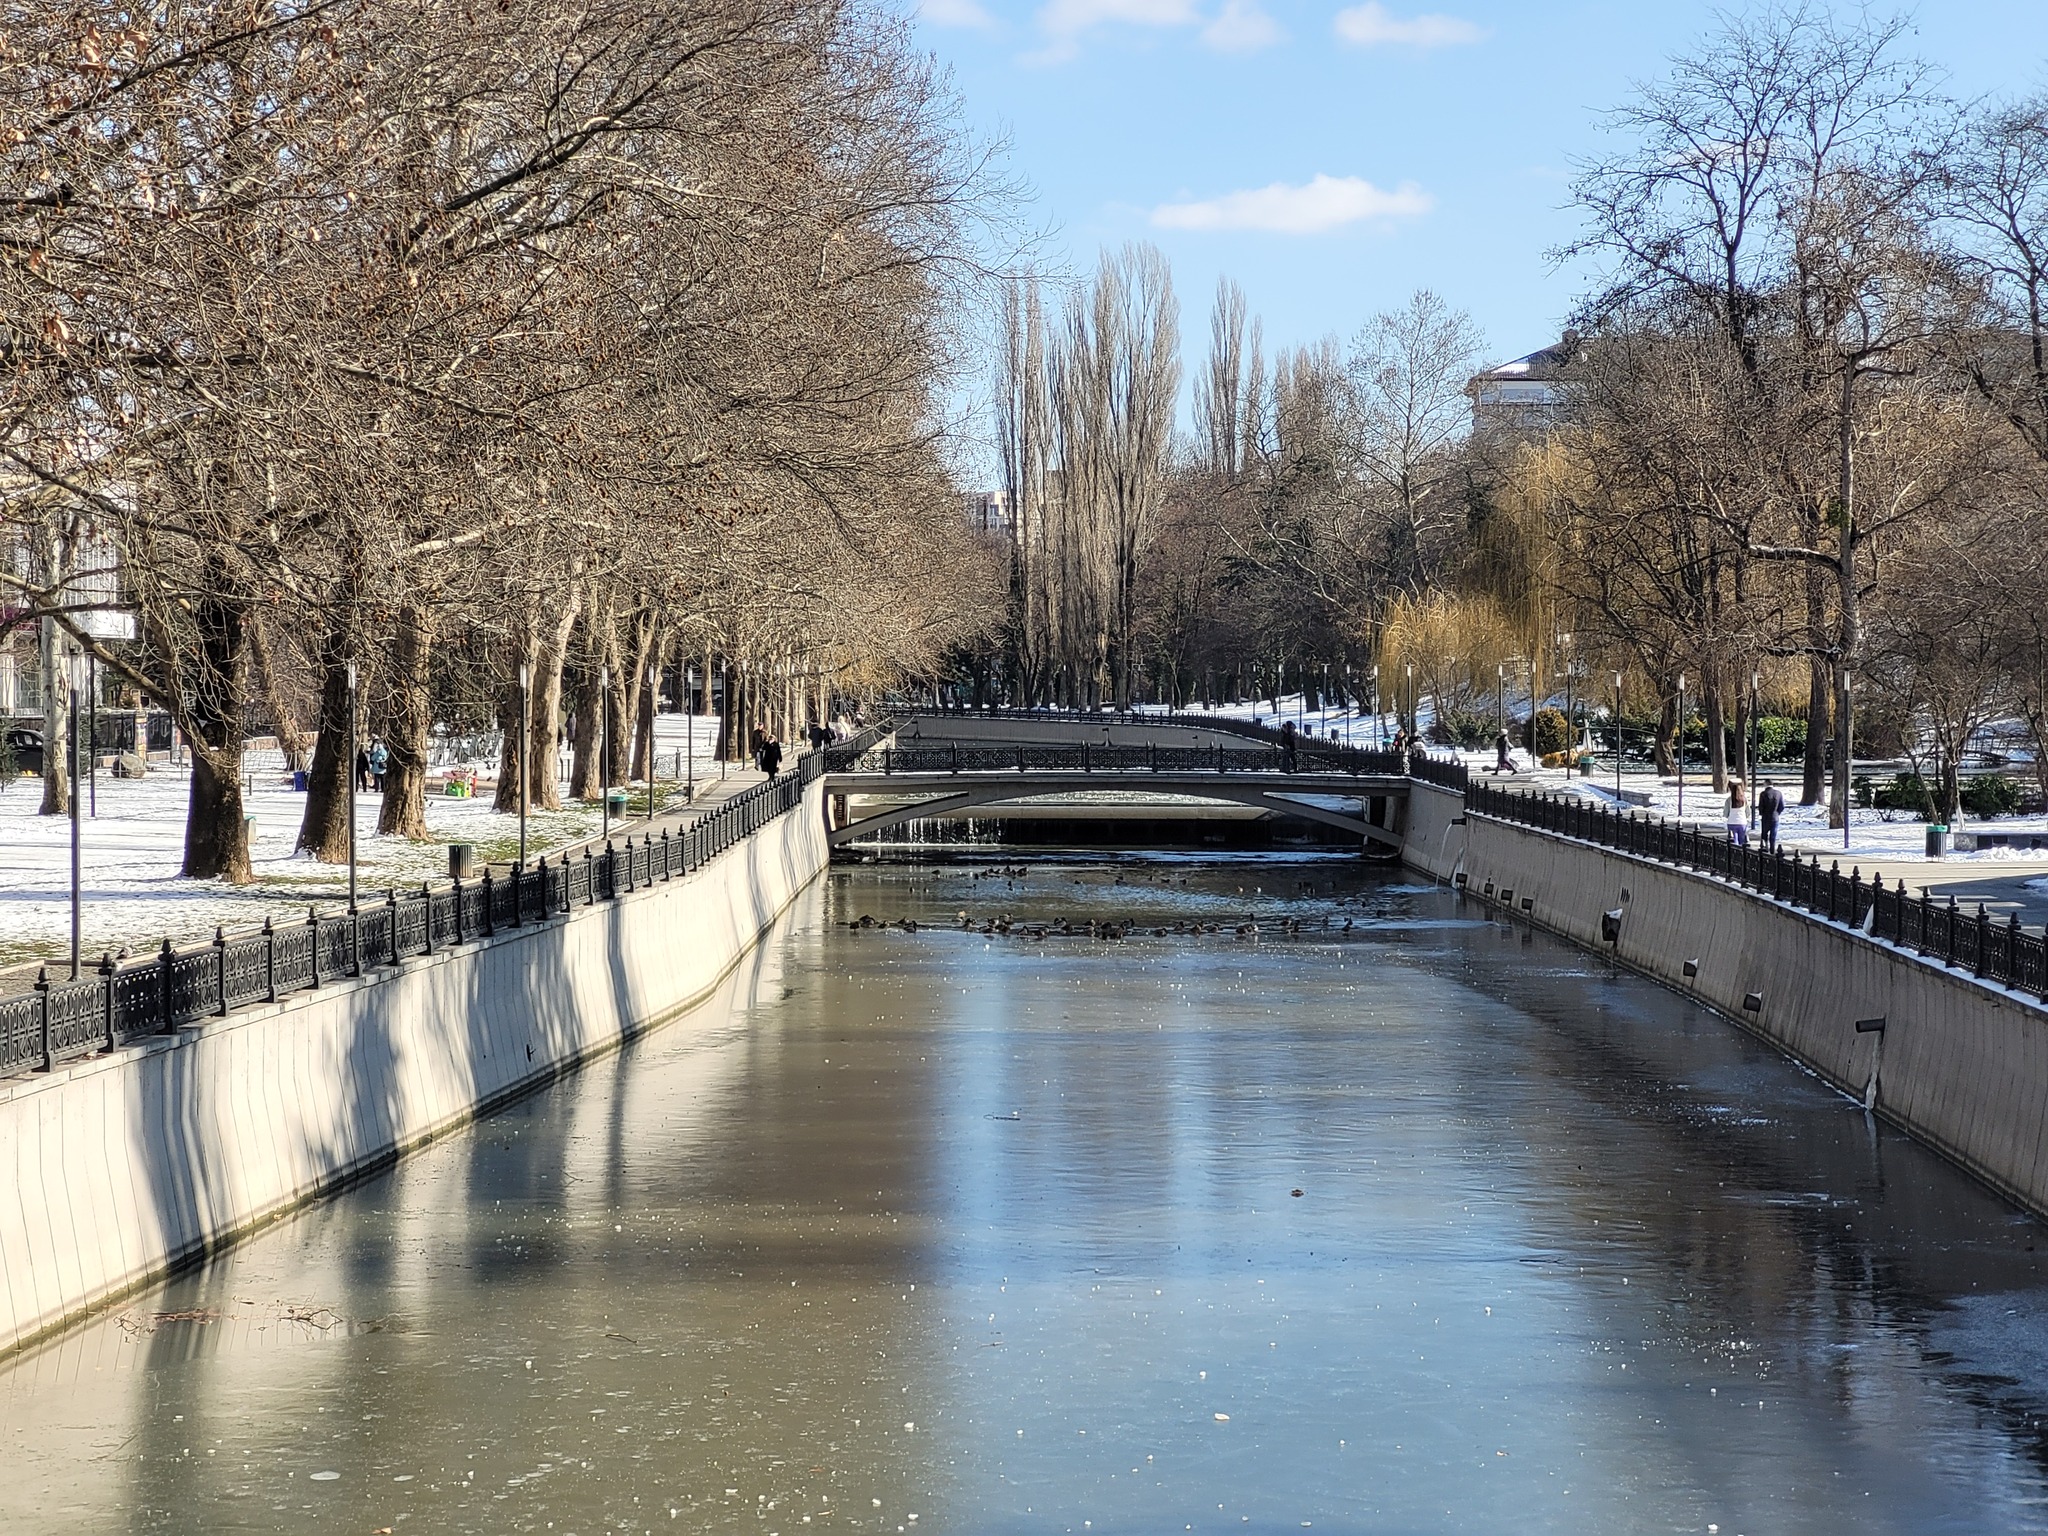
left=0, top=727, right=885, bottom=1075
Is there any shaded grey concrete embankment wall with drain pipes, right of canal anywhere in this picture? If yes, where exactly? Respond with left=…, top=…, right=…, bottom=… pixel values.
left=1409, top=786, right=2048, bottom=1212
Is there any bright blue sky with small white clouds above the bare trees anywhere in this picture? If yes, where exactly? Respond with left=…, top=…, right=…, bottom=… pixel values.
left=920, top=0, right=2048, bottom=365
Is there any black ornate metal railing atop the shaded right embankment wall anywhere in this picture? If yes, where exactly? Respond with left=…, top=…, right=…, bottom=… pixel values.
left=1464, top=782, right=2048, bottom=999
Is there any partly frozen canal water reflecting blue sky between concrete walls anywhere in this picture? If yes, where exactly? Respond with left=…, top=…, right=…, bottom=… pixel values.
left=0, top=856, right=2048, bottom=1536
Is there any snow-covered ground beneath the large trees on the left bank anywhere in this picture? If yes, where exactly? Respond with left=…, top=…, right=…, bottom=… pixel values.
left=0, top=715, right=719, bottom=989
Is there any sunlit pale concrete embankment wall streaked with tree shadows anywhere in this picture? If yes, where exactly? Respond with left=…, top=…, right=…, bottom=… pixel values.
left=0, top=784, right=829, bottom=1350
